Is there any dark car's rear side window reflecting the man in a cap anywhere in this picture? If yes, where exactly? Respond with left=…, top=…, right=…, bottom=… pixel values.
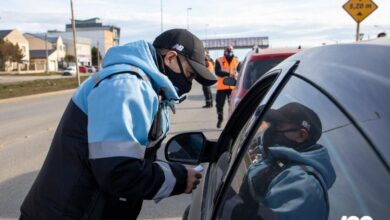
left=217, top=77, right=390, bottom=219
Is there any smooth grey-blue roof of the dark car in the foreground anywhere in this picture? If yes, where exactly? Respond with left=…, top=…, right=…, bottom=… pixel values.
left=288, top=43, right=390, bottom=163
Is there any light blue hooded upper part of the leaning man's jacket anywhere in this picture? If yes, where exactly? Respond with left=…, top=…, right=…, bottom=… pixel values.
left=72, top=41, right=178, bottom=151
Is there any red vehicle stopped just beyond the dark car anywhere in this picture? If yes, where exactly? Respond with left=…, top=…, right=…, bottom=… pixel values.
left=229, top=48, right=301, bottom=115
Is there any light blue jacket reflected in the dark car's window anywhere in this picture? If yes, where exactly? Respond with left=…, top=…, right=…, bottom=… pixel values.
left=247, top=145, right=336, bottom=220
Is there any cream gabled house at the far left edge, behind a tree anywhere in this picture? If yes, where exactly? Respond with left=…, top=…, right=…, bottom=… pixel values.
left=0, top=29, right=30, bottom=71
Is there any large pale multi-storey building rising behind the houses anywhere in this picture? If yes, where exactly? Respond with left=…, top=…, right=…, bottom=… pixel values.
left=66, top=18, right=120, bottom=56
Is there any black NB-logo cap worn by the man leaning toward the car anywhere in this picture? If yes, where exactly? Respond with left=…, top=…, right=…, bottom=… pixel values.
left=153, top=29, right=217, bottom=86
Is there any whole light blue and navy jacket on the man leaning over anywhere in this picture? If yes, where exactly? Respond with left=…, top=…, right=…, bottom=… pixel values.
left=21, top=41, right=187, bottom=220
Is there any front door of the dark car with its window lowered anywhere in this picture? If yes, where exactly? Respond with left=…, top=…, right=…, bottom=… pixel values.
left=188, top=62, right=295, bottom=219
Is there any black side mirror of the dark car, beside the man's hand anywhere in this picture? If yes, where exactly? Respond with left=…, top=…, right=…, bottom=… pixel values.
left=165, top=132, right=207, bottom=165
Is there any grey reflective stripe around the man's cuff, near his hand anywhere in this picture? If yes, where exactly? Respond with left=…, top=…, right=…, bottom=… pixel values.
left=153, top=161, right=176, bottom=202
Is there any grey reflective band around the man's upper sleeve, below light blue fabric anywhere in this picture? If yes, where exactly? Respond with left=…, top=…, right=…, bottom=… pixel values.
left=88, top=141, right=146, bottom=159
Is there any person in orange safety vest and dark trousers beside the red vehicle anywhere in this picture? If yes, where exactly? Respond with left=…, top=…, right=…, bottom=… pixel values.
left=215, top=46, right=240, bottom=128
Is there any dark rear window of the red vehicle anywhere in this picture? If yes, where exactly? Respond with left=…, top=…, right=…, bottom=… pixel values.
left=243, top=58, right=285, bottom=89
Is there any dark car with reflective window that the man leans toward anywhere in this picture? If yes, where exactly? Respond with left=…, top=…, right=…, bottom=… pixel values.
left=165, top=43, right=390, bottom=220
